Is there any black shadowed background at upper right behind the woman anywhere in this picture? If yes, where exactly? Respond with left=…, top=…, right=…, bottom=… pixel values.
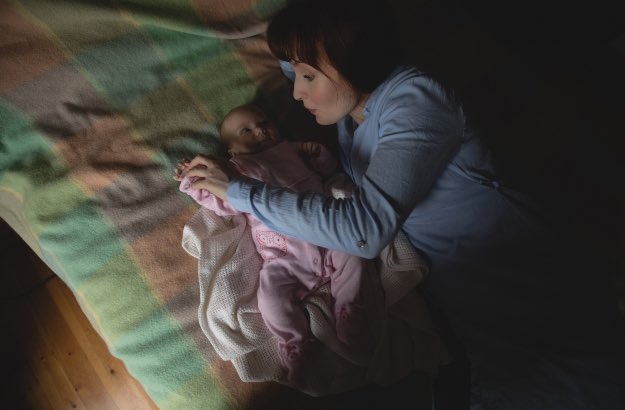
left=390, top=0, right=625, bottom=310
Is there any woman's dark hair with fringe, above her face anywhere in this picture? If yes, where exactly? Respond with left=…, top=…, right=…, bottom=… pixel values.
left=267, top=0, right=400, bottom=93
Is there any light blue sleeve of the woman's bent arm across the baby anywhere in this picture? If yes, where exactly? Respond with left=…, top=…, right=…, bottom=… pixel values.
left=227, top=79, right=464, bottom=258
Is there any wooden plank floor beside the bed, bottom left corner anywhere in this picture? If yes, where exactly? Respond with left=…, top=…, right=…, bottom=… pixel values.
left=0, top=220, right=157, bottom=410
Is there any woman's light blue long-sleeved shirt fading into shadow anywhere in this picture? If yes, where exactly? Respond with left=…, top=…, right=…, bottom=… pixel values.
left=227, top=67, right=528, bottom=267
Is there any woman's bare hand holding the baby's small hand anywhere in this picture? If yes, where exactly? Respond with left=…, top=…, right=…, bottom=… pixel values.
left=174, top=155, right=234, bottom=200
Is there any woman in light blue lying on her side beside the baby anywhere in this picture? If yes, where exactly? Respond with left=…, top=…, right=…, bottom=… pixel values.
left=180, top=0, right=625, bottom=409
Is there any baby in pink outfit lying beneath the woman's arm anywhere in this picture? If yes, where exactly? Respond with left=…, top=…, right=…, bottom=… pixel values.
left=175, top=105, right=370, bottom=379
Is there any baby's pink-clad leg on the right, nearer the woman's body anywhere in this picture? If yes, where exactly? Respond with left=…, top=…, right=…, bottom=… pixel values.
left=326, top=250, right=373, bottom=351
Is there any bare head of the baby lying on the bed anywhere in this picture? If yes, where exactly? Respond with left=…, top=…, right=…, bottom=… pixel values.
left=219, top=105, right=280, bottom=156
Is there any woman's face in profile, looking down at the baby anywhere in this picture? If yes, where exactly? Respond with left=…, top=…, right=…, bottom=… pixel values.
left=291, top=61, right=364, bottom=125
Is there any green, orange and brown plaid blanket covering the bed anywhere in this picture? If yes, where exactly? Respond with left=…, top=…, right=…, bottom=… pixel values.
left=0, top=0, right=312, bottom=409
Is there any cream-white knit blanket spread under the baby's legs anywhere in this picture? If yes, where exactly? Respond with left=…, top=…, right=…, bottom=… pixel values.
left=182, top=208, right=448, bottom=396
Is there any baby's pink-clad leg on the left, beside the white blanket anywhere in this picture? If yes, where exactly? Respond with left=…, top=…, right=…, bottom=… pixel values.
left=258, top=260, right=314, bottom=379
